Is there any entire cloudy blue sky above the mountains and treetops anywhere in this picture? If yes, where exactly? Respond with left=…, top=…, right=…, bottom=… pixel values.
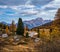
left=0, top=0, right=60, bottom=23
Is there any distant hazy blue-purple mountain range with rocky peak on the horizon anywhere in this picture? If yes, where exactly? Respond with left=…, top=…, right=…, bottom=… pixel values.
left=1, top=18, right=51, bottom=29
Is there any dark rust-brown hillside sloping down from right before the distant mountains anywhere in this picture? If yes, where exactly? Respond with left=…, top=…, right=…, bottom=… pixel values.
left=32, top=19, right=60, bottom=31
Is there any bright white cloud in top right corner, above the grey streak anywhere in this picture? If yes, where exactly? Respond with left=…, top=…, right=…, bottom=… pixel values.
left=42, top=0, right=60, bottom=9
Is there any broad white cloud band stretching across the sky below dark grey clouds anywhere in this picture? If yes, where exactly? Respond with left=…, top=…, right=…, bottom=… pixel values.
left=0, top=0, right=60, bottom=19
